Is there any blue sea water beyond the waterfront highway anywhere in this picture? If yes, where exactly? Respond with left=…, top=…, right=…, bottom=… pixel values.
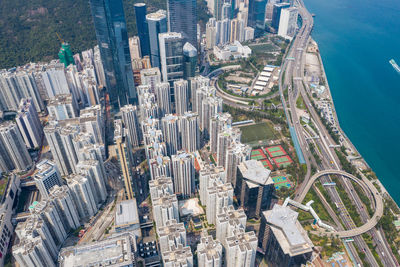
left=304, top=0, right=400, bottom=204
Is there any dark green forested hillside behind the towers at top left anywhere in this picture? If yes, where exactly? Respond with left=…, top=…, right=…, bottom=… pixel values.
left=0, top=0, right=208, bottom=69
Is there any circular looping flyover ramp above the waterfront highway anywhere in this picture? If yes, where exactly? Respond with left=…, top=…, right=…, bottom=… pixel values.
left=297, top=170, right=383, bottom=238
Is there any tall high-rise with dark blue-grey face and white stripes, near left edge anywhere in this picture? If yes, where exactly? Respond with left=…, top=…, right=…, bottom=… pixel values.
left=15, top=98, right=43, bottom=148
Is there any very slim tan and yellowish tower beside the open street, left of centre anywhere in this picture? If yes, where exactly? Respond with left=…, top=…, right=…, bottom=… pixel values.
left=114, top=120, right=135, bottom=199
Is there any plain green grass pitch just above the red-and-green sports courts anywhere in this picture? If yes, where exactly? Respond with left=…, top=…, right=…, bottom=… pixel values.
left=240, top=122, right=276, bottom=143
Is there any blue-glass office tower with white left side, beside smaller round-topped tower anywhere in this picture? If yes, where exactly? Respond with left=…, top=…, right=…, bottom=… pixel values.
left=158, top=32, right=183, bottom=85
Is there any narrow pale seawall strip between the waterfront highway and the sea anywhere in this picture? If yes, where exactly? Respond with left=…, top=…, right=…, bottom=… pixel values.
left=306, top=37, right=392, bottom=199
